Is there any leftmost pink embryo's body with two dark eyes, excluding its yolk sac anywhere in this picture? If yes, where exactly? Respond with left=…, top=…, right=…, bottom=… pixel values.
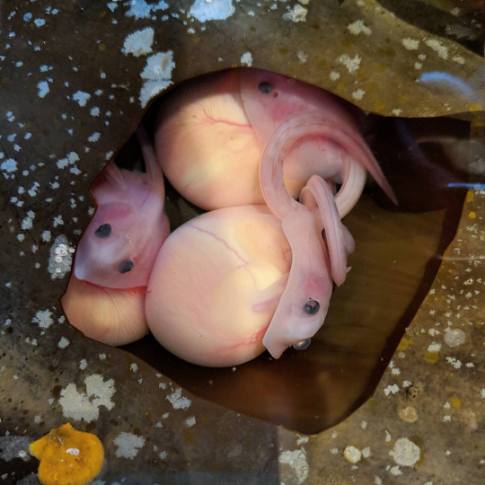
left=74, top=127, right=166, bottom=289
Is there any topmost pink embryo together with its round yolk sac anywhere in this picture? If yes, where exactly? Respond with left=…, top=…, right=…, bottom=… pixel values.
left=155, top=69, right=392, bottom=212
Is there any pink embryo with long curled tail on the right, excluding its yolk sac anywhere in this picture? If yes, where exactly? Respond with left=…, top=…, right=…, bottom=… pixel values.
left=260, top=114, right=362, bottom=358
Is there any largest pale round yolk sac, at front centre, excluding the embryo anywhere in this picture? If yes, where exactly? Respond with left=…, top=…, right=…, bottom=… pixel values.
left=145, top=206, right=291, bottom=367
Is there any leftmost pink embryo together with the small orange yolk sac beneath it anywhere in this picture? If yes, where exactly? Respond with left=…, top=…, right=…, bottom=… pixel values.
left=61, top=132, right=170, bottom=345
